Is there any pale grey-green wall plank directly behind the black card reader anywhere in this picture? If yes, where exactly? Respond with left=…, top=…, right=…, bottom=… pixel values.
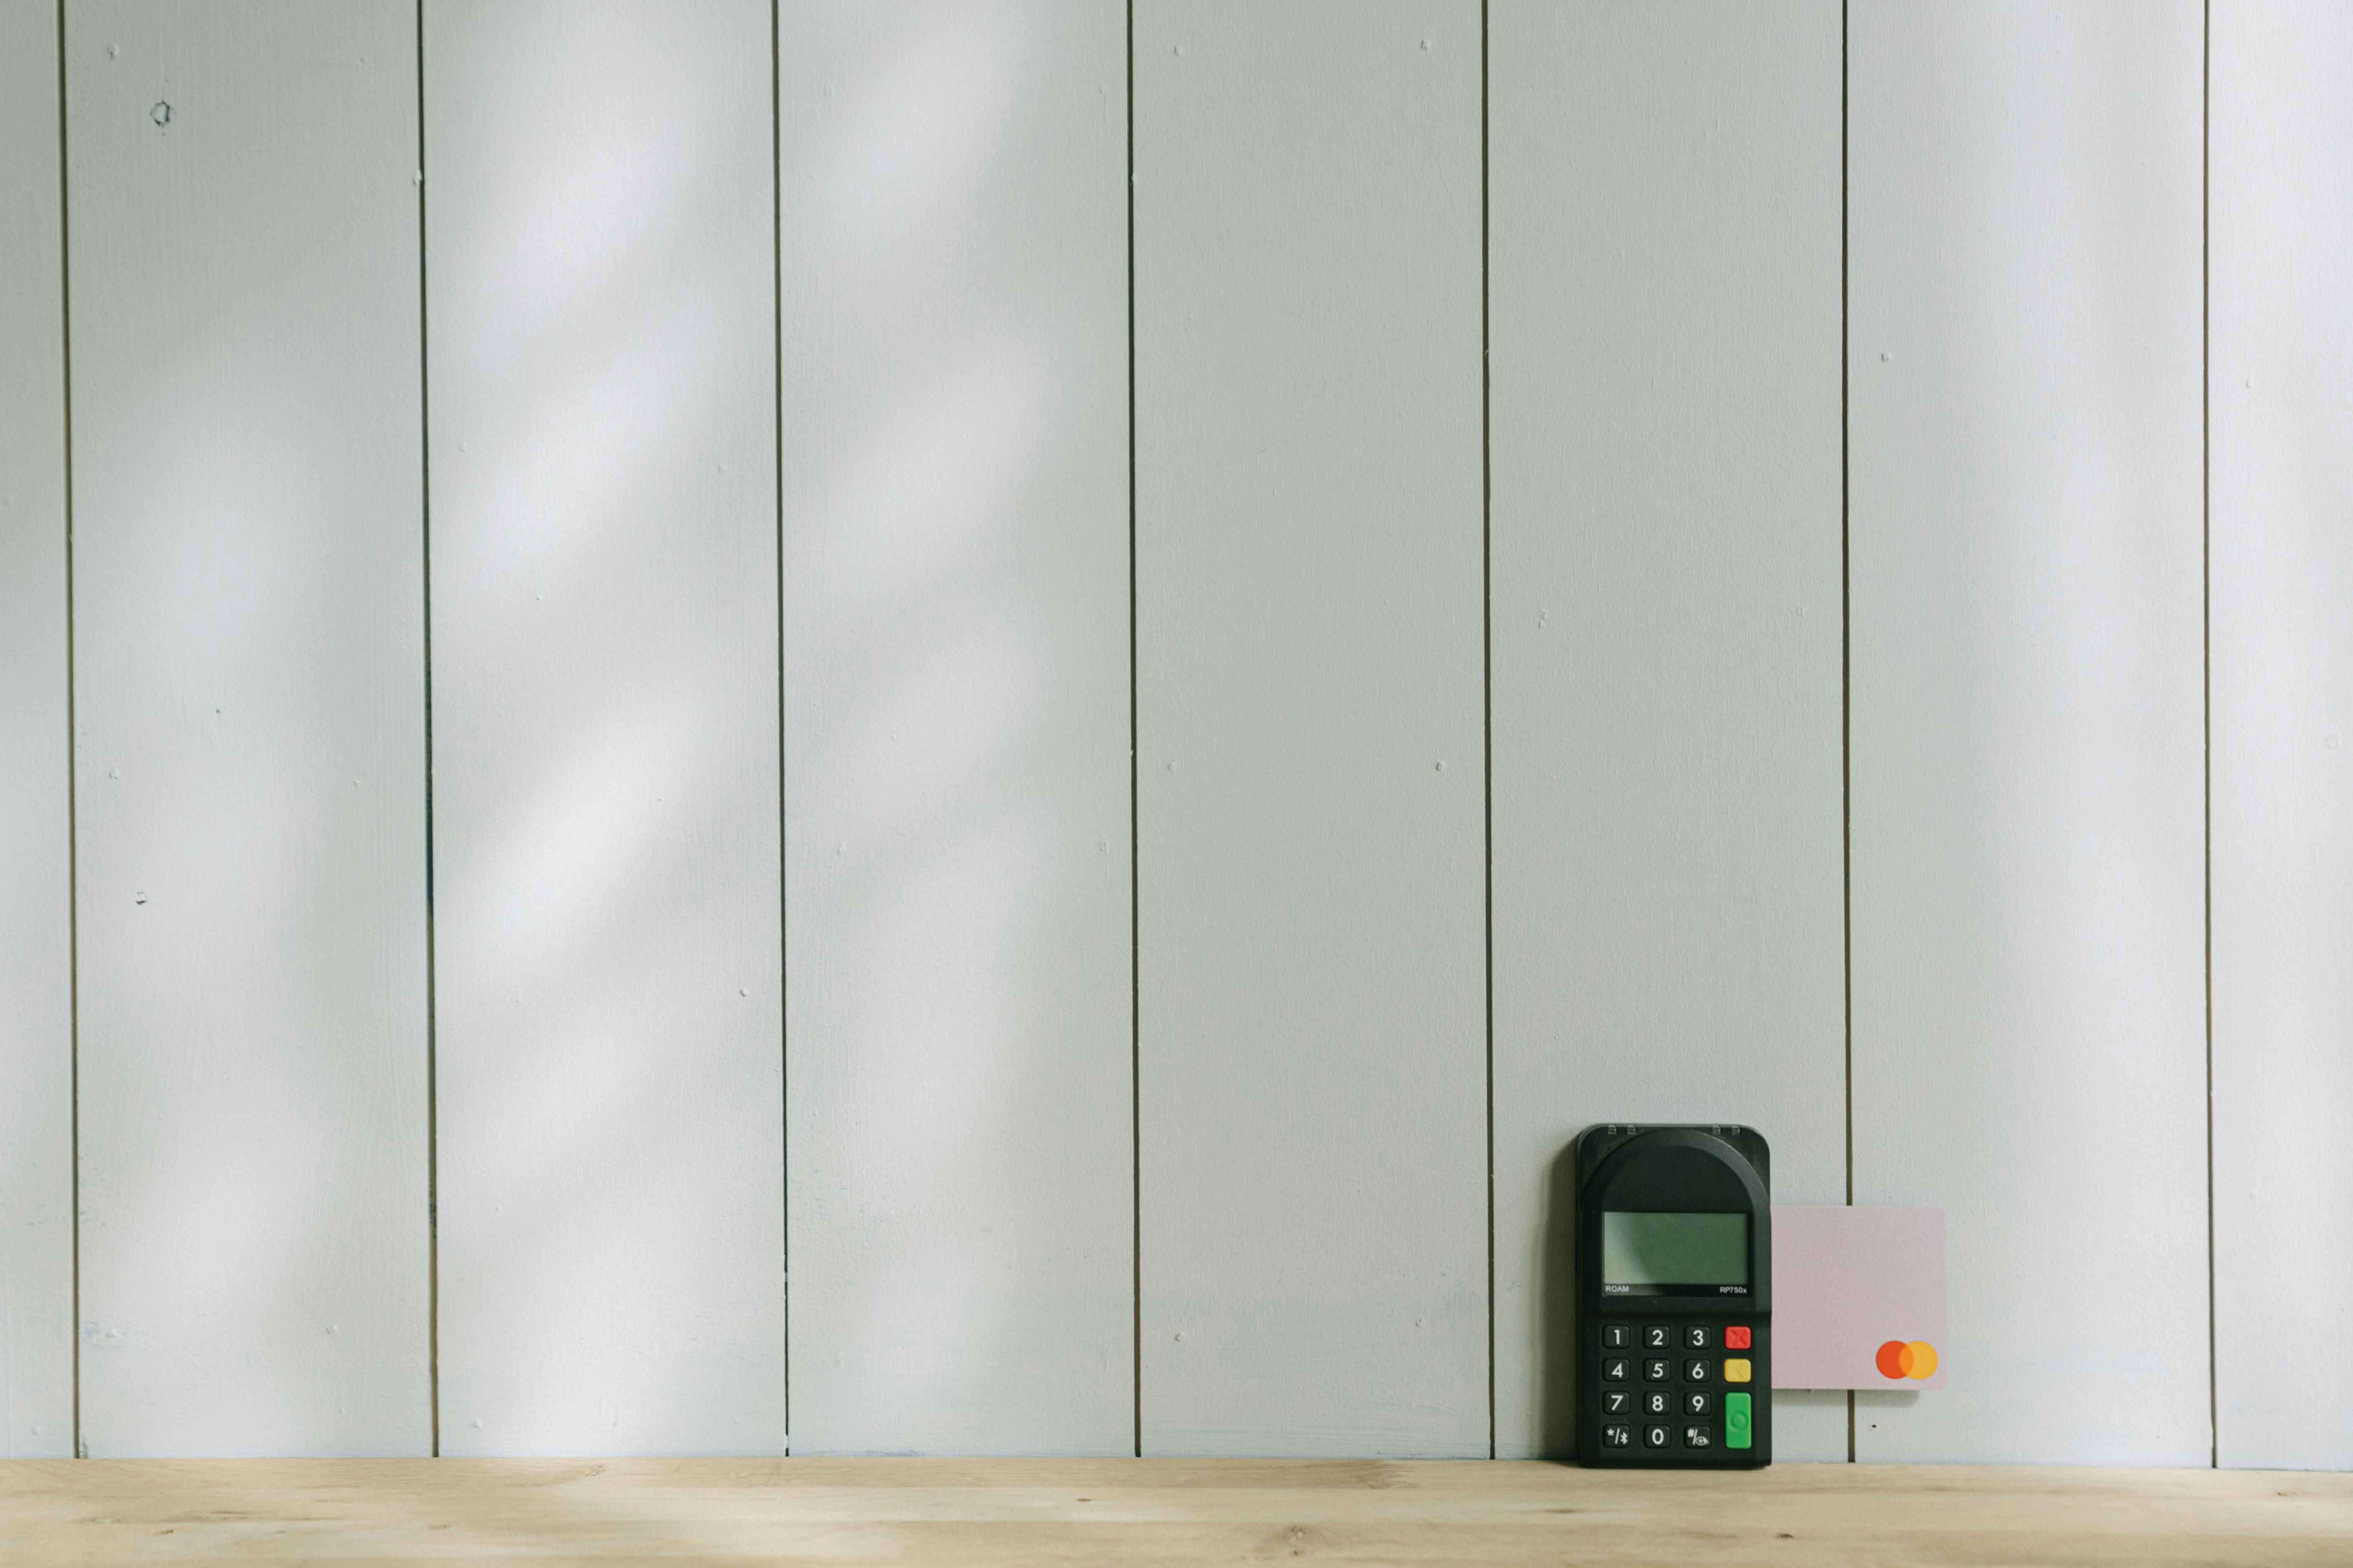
left=1487, top=0, right=1847, bottom=1460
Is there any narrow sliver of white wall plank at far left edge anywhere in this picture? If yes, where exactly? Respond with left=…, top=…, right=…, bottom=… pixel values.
left=0, top=0, right=73, bottom=1460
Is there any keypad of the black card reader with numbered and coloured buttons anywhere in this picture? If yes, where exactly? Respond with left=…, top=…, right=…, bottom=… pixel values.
left=1598, top=1323, right=1765, bottom=1465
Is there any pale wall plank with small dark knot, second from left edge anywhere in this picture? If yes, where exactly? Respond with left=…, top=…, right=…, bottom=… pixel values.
left=66, top=0, right=430, bottom=1458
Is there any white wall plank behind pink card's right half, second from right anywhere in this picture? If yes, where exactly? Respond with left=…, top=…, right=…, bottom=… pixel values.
left=1847, top=0, right=2210, bottom=1465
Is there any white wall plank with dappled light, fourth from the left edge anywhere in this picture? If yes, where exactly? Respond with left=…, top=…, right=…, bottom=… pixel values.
left=776, top=0, right=1134, bottom=1453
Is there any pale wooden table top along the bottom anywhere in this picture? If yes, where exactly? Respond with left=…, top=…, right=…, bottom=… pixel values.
left=0, top=1460, right=2353, bottom=1568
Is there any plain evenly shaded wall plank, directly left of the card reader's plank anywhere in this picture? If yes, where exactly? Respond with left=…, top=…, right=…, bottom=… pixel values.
left=1134, top=0, right=1490, bottom=1455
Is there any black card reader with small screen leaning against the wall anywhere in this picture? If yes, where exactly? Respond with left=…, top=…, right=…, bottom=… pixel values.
left=1577, top=1124, right=1772, bottom=1469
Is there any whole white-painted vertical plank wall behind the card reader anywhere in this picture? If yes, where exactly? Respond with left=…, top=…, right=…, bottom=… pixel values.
left=0, top=0, right=2353, bottom=1467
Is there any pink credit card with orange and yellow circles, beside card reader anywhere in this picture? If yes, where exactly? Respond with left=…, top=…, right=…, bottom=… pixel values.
left=1772, top=1204, right=1944, bottom=1392
